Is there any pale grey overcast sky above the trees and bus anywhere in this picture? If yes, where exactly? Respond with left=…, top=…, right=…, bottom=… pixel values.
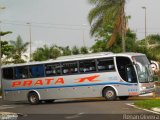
left=0, top=0, right=160, bottom=51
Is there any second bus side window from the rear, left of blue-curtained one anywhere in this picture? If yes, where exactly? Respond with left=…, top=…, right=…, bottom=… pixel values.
left=14, top=66, right=28, bottom=79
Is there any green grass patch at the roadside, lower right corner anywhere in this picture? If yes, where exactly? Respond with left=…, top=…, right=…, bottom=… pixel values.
left=134, top=99, right=160, bottom=109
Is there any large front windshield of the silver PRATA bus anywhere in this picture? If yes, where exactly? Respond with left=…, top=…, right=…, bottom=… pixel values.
left=134, top=56, right=153, bottom=83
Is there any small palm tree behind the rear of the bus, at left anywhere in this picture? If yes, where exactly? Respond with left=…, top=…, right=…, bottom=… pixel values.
left=10, top=36, right=29, bottom=63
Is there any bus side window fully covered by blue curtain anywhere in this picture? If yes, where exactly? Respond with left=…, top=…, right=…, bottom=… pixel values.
left=29, top=65, right=44, bottom=78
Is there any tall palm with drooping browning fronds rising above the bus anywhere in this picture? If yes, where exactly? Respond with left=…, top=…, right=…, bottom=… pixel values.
left=88, top=0, right=126, bottom=51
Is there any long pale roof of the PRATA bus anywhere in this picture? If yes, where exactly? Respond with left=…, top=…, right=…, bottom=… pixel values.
left=2, top=52, right=144, bottom=68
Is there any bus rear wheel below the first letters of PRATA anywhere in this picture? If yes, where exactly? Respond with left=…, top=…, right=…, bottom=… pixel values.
left=28, top=92, right=40, bottom=105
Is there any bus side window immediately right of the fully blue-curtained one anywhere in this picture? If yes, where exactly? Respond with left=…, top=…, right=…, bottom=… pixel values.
left=45, top=63, right=61, bottom=76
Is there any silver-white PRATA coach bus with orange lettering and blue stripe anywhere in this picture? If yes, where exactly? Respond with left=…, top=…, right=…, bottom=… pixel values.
left=2, top=52, right=154, bottom=104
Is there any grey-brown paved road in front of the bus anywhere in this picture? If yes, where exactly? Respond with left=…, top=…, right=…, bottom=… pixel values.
left=0, top=99, right=159, bottom=120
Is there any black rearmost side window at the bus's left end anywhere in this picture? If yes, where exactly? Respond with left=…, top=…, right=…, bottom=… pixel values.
left=2, top=68, right=13, bottom=80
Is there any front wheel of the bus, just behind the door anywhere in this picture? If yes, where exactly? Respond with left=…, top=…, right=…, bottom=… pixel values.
left=103, top=87, right=117, bottom=101
